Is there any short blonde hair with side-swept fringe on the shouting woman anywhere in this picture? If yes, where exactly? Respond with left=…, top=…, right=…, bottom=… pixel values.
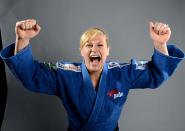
left=80, top=27, right=109, bottom=49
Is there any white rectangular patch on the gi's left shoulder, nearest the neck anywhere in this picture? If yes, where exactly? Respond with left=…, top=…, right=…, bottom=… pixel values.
left=56, top=62, right=81, bottom=72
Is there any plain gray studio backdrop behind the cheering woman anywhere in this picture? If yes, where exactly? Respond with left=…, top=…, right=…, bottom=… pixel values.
left=0, top=0, right=185, bottom=131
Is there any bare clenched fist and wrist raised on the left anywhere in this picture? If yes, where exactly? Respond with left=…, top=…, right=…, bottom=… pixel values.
left=14, top=19, right=41, bottom=54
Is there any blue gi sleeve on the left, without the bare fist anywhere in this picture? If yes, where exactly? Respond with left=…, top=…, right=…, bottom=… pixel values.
left=0, top=44, right=57, bottom=95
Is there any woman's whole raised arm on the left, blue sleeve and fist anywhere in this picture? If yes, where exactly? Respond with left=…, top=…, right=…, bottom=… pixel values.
left=0, top=20, right=58, bottom=95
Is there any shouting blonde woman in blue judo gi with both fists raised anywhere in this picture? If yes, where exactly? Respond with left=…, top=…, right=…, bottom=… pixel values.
left=1, top=19, right=184, bottom=131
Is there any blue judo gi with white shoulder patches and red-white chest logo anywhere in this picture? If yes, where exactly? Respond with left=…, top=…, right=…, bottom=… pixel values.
left=1, top=44, right=184, bottom=131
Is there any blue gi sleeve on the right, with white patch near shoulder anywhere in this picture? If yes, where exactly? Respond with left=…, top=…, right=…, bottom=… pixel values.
left=127, top=45, right=184, bottom=89
